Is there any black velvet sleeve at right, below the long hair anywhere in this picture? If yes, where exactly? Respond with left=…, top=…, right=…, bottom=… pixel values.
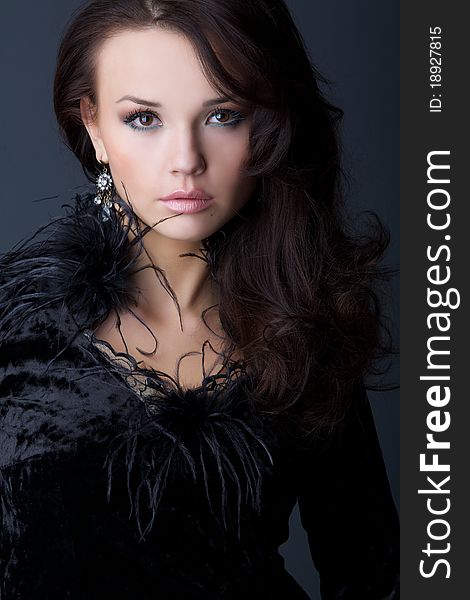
left=297, top=382, right=399, bottom=600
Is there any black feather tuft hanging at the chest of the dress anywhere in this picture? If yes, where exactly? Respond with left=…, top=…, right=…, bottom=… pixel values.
left=104, top=378, right=274, bottom=539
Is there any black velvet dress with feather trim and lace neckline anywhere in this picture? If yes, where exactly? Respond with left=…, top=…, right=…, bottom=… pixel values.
left=0, top=195, right=399, bottom=600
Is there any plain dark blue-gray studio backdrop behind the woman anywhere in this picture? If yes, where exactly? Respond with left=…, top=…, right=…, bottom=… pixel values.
left=0, top=0, right=399, bottom=600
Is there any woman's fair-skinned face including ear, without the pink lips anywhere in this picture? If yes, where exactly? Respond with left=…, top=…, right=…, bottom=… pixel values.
left=81, top=28, right=256, bottom=241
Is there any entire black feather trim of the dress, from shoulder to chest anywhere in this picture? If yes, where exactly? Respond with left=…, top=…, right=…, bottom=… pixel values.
left=0, top=193, right=280, bottom=539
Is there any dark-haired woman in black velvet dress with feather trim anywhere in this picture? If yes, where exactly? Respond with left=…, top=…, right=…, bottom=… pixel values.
left=0, top=0, right=399, bottom=600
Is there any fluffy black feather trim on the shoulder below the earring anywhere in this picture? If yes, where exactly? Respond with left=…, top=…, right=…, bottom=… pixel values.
left=0, top=193, right=142, bottom=345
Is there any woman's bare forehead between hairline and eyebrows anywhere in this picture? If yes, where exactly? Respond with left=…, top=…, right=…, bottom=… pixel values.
left=96, top=27, right=217, bottom=104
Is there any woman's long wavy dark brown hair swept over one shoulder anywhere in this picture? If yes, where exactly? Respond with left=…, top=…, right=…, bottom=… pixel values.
left=54, top=0, right=393, bottom=429
